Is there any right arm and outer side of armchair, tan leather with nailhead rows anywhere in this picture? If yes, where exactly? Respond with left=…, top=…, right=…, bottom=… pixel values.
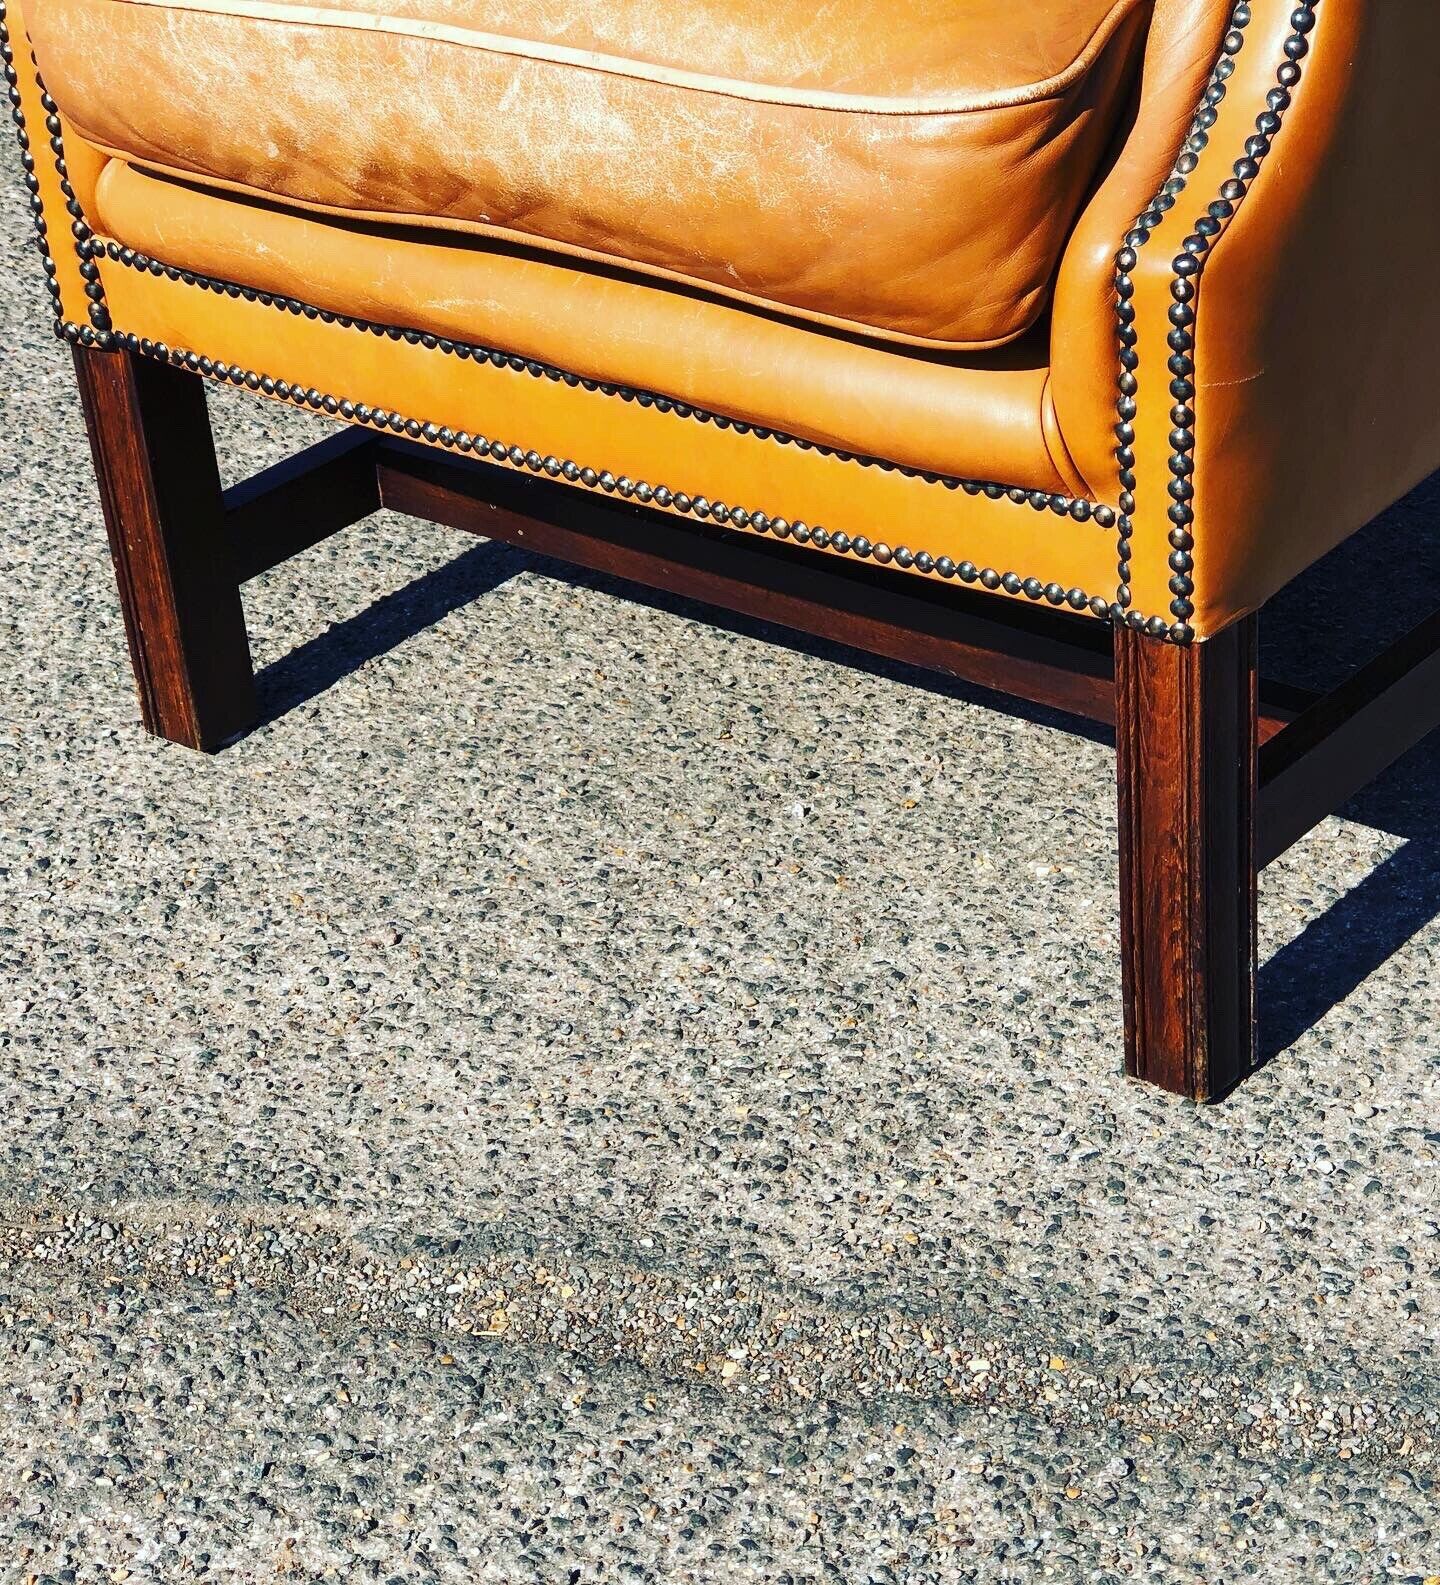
left=1050, top=0, right=1440, bottom=637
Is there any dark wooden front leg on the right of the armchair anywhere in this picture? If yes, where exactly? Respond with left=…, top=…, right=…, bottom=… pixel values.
left=1115, top=617, right=1258, bottom=1100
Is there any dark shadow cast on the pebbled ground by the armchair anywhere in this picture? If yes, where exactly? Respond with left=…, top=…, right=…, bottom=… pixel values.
left=257, top=474, right=1440, bottom=1064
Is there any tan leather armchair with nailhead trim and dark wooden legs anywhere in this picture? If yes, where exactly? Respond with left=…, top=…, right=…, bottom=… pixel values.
left=5, top=0, right=1440, bottom=1097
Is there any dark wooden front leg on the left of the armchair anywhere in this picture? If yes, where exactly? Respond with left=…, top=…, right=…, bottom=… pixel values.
left=74, top=347, right=257, bottom=750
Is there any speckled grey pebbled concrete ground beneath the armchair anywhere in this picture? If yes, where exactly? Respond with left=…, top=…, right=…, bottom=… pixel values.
left=0, top=167, right=1440, bottom=1585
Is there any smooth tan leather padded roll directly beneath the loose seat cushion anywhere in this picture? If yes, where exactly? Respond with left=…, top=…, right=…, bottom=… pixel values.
left=89, top=163, right=1072, bottom=491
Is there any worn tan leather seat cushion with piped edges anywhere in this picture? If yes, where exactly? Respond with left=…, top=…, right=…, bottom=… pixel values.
left=30, top=0, right=1149, bottom=349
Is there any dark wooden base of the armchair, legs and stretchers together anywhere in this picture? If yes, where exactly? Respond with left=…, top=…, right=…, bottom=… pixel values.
left=74, top=347, right=1440, bottom=1100
